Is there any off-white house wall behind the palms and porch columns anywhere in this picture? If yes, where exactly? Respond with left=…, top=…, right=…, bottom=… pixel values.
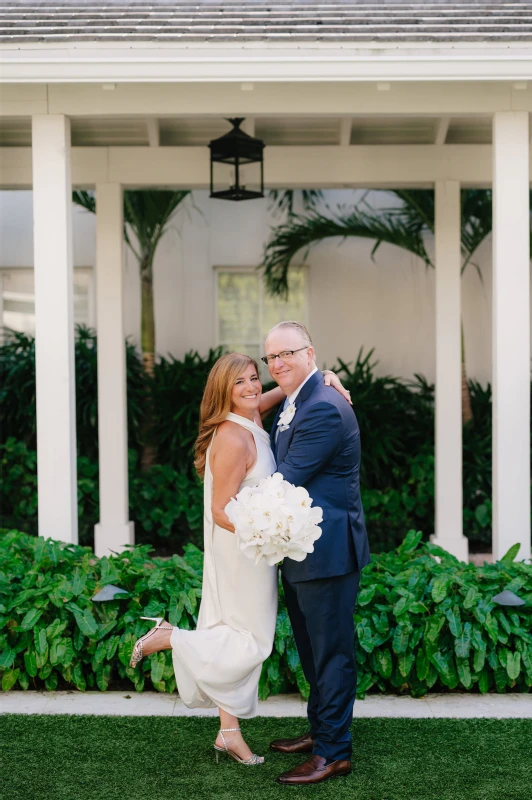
left=0, top=191, right=528, bottom=383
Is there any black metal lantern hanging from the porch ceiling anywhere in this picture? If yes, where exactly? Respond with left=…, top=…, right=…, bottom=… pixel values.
left=209, top=118, right=265, bottom=200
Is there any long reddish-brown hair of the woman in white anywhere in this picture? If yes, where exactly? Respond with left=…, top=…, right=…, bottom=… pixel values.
left=194, top=353, right=259, bottom=478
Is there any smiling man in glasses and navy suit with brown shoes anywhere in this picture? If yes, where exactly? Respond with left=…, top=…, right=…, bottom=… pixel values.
left=263, top=322, right=369, bottom=784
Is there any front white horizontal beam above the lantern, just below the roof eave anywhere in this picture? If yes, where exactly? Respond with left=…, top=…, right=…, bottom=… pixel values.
left=0, top=81, right=532, bottom=119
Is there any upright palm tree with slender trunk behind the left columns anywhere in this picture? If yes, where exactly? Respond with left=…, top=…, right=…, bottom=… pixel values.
left=72, top=190, right=190, bottom=470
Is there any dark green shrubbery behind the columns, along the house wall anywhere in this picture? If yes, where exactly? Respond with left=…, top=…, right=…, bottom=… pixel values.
left=0, top=328, right=532, bottom=552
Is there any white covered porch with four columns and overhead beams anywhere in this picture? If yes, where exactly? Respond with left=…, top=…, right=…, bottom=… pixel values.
left=0, top=54, right=532, bottom=560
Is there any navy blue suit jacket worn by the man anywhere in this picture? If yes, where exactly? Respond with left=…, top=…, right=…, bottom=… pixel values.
left=271, top=370, right=370, bottom=582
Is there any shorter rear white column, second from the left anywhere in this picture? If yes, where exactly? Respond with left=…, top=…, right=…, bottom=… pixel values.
left=94, top=183, right=134, bottom=556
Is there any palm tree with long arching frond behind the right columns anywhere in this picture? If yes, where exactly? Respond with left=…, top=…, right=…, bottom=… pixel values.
left=264, top=189, right=500, bottom=422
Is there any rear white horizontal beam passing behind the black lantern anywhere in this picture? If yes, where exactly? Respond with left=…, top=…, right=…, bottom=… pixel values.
left=0, top=144, right=532, bottom=189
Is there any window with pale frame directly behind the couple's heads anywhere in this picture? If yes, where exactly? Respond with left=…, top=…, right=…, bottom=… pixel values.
left=216, top=267, right=308, bottom=375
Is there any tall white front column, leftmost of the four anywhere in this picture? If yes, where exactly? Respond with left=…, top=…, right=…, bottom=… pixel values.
left=32, top=114, right=78, bottom=543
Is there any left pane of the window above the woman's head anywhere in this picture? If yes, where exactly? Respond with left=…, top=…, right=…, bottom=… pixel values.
left=218, top=272, right=260, bottom=349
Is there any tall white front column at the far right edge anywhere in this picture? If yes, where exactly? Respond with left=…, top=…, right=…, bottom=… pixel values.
left=492, top=111, right=530, bottom=559
